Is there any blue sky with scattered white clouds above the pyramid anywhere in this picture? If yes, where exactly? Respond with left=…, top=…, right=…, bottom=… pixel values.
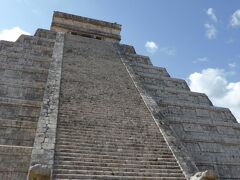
left=0, top=0, right=240, bottom=119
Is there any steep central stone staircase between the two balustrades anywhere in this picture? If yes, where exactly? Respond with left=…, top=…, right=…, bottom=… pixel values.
left=53, top=35, right=185, bottom=180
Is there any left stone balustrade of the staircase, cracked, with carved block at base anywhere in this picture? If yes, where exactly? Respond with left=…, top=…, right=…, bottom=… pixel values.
left=28, top=32, right=64, bottom=180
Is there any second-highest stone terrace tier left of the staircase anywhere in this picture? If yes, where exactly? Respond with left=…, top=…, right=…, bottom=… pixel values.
left=16, top=34, right=55, bottom=48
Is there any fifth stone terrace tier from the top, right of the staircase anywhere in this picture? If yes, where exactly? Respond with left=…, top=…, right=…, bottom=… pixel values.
left=144, top=85, right=213, bottom=106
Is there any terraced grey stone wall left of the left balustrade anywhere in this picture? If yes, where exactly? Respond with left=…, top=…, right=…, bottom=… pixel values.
left=0, top=30, right=54, bottom=180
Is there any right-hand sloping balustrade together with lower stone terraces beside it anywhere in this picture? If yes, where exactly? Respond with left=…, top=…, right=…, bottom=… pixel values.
left=122, top=32, right=240, bottom=180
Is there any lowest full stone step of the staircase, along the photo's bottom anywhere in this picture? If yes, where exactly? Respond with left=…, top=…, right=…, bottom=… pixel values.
left=54, top=169, right=183, bottom=177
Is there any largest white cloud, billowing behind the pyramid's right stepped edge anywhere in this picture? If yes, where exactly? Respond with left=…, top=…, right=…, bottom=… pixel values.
left=188, top=68, right=240, bottom=121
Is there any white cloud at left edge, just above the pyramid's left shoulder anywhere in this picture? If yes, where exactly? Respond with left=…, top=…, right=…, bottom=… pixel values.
left=0, top=26, right=30, bottom=41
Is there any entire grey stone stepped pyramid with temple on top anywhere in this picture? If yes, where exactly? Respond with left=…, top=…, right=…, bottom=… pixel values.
left=0, top=11, right=240, bottom=180
